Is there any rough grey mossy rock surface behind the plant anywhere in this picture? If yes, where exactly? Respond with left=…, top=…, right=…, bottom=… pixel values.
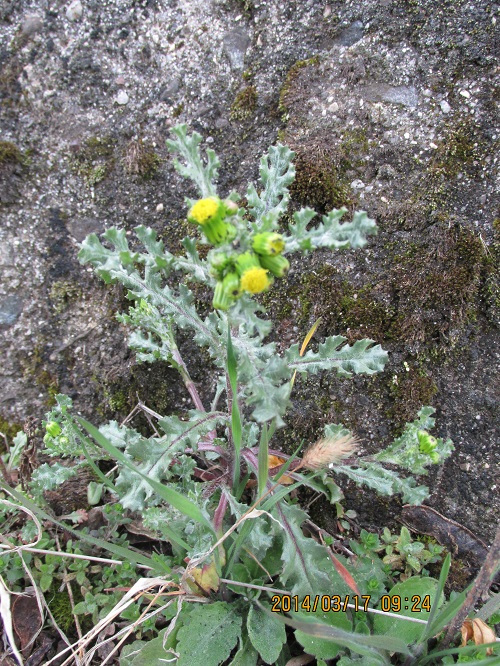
left=0, top=0, right=500, bottom=541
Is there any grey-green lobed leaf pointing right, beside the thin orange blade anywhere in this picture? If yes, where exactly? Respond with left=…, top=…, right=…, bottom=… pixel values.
left=285, top=335, right=387, bottom=377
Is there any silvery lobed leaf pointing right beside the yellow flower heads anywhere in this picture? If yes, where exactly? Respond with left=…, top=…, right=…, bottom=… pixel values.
left=285, top=208, right=377, bottom=252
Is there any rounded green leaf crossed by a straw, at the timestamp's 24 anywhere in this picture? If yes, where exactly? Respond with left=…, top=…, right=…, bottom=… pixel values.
left=373, top=576, right=443, bottom=645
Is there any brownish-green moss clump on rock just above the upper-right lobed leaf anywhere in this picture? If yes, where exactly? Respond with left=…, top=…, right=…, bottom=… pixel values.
left=290, top=149, right=352, bottom=213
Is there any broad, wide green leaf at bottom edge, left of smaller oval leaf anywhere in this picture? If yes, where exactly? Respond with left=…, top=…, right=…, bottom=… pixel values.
left=176, top=601, right=242, bottom=666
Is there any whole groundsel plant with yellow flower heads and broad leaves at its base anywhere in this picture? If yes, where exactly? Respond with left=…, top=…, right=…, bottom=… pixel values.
left=8, top=125, right=492, bottom=666
